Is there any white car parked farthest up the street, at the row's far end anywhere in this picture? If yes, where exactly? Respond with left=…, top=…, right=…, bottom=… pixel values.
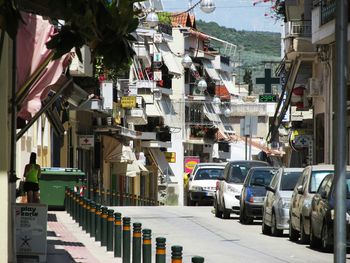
left=187, top=163, right=225, bottom=205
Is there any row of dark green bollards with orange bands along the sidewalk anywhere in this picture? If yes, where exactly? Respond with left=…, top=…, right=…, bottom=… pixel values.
left=64, top=188, right=204, bottom=263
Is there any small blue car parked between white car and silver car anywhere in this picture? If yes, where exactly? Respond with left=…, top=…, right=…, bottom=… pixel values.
left=239, top=167, right=278, bottom=224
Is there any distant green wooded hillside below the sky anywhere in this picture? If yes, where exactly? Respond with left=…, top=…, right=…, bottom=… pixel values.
left=196, top=20, right=281, bottom=87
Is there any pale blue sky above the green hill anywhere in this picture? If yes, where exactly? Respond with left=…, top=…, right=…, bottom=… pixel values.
left=162, top=0, right=282, bottom=32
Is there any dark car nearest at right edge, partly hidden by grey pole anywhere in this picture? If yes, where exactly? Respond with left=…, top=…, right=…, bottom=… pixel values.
left=310, top=173, right=350, bottom=251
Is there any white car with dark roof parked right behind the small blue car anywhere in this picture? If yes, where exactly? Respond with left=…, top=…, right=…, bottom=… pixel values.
left=214, top=160, right=270, bottom=219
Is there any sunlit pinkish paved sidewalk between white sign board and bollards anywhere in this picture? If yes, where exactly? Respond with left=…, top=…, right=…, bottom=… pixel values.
left=47, top=211, right=122, bottom=263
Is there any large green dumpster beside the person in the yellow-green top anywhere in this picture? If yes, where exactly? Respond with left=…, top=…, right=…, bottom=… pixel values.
left=39, top=167, right=85, bottom=209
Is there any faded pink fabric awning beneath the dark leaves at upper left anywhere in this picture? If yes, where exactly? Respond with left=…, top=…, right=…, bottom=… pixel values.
left=16, top=13, right=70, bottom=121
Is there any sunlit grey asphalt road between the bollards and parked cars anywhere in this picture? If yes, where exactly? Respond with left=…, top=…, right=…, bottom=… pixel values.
left=108, top=206, right=350, bottom=263
